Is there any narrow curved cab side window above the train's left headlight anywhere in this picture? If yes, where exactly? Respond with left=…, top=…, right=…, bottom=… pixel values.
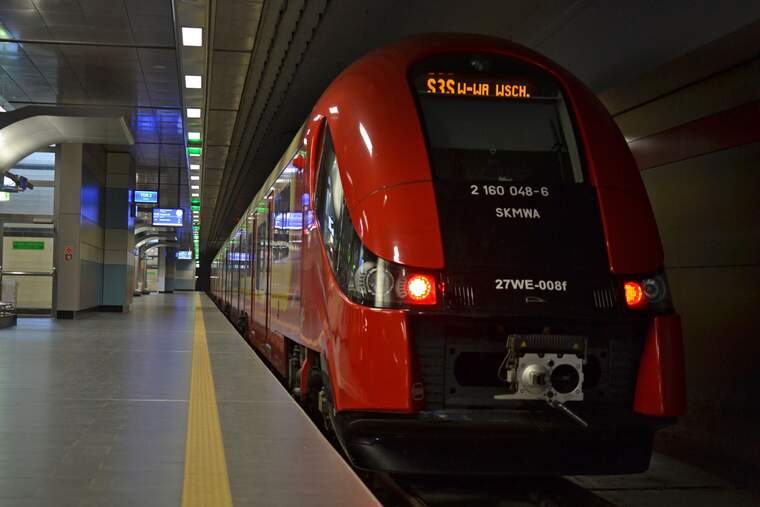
left=314, top=126, right=346, bottom=268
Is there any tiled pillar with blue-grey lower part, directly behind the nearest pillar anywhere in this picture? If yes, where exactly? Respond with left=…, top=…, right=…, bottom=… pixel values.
left=102, top=153, right=136, bottom=312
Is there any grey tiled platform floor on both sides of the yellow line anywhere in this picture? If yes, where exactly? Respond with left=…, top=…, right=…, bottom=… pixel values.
left=0, top=293, right=376, bottom=507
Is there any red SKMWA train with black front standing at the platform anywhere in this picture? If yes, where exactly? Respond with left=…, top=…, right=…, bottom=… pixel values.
left=211, top=35, right=685, bottom=474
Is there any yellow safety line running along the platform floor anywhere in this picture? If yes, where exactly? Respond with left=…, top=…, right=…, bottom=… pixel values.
left=182, top=294, right=232, bottom=507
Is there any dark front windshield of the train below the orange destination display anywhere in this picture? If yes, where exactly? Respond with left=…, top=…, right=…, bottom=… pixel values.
left=420, top=94, right=583, bottom=184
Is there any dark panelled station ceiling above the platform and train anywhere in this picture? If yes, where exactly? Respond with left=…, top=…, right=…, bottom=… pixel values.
left=0, top=0, right=760, bottom=262
